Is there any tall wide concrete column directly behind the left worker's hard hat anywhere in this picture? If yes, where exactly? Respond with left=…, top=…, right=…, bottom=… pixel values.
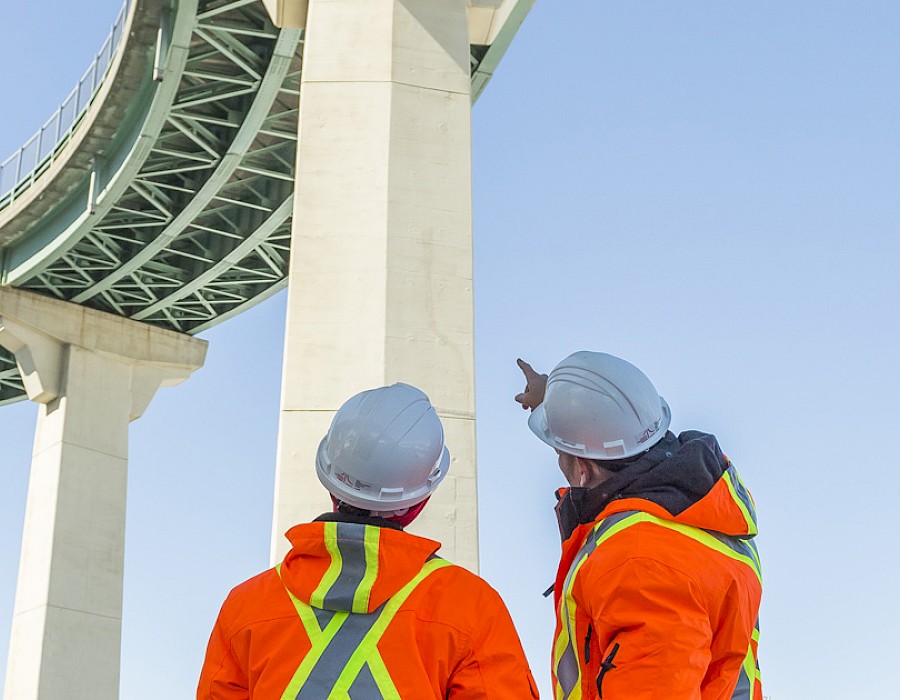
left=272, top=0, right=478, bottom=569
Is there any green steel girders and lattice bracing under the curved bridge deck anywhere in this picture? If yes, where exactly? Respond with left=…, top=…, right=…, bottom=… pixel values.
left=0, top=0, right=533, bottom=405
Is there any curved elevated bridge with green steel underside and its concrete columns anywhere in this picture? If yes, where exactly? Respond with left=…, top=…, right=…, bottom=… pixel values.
left=0, top=0, right=533, bottom=700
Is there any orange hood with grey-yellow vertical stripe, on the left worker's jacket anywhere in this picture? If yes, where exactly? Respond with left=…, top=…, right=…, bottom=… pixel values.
left=281, top=513, right=441, bottom=613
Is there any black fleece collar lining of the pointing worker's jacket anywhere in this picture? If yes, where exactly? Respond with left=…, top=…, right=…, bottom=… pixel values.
left=556, top=430, right=728, bottom=541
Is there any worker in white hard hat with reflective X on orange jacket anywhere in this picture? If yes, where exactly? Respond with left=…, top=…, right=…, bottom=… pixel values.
left=197, top=384, right=538, bottom=700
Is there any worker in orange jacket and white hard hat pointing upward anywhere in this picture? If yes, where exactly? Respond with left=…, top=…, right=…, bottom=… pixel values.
left=516, top=351, right=762, bottom=700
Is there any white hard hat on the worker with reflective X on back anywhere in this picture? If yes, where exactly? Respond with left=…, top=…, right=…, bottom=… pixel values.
left=316, top=383, right=450, bottom=511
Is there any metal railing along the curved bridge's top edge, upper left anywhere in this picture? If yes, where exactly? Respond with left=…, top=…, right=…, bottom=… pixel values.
left=0, top=0, right=133, bottom=210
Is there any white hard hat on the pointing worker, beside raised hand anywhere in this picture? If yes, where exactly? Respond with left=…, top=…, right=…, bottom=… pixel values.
left=528, top=350, right=672, bottom=460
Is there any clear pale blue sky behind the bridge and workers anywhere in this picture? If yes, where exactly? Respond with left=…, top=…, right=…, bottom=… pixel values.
left=0, top=0, right=900, bottom=700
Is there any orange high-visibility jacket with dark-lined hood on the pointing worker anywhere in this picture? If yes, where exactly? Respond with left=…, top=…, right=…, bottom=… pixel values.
left=552, top=432, right=762, bottom=700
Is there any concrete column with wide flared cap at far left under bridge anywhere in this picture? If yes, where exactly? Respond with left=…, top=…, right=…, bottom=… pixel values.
left=0, top=288, right=206, bottom=700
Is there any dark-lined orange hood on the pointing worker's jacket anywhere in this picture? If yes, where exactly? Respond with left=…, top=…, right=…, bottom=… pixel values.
left=556, top=431, right=757, bottom=540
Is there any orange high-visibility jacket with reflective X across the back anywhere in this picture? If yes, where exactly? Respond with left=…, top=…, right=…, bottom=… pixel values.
left=197, top=514, right=538, bottom=700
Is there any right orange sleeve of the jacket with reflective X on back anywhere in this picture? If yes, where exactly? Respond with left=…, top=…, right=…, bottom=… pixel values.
left=447, top=584, right=538, bottom=700
